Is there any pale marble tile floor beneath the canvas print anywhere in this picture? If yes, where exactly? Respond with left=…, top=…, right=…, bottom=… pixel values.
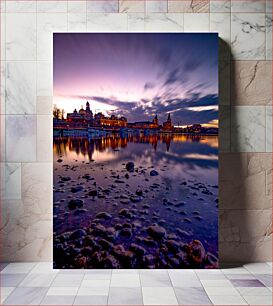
left=0, top=262, right=273, bottom=305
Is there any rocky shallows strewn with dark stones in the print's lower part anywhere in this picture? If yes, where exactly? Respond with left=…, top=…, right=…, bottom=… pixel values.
left=53, top=156, right=218, bottom=269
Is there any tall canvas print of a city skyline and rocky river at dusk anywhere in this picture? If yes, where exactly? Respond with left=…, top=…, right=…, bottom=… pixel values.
left=53, top=33, right=218, bottom=269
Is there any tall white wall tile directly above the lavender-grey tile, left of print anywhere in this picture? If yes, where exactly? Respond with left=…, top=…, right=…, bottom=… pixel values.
left=5, top=61, right=36, bottom=115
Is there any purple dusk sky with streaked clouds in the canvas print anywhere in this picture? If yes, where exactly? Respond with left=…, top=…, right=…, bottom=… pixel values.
left=53, top=33, right=218, bottom=126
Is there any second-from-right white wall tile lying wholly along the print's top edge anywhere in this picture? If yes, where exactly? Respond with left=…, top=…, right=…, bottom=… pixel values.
left=145, top=13, right=183, bottom=32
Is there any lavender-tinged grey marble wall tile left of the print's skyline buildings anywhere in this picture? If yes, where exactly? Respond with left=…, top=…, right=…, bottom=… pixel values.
left=6, top=115, right=36, bottom=162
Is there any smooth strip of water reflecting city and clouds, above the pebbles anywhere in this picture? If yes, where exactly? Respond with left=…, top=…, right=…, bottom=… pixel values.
left=53, top=135, right=218, bottom=184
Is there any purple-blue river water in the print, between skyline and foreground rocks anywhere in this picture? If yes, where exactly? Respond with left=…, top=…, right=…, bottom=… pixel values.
left=54, top=135, right=218, bottom=268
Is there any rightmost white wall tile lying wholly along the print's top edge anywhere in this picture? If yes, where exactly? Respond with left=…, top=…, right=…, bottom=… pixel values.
left=184, top=13, right=210, bottom=32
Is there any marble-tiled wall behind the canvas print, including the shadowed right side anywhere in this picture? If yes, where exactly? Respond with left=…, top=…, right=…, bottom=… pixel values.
left=0, top=0, right=272, bottom=262
